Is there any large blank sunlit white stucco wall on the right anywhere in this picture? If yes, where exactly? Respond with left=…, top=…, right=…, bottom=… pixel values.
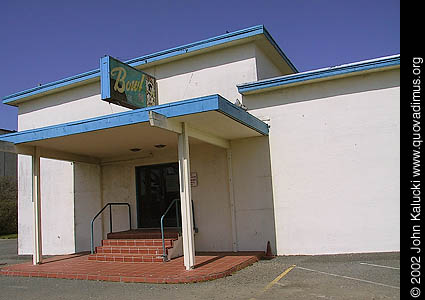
left=244, top=70, right=400, bottom=255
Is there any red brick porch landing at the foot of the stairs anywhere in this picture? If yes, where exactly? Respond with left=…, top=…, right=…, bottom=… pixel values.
left=0, top=252, right=264, bottom=283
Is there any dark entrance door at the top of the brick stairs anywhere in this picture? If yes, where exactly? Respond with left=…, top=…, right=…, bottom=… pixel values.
left=136, top=163, right=180, bottom=228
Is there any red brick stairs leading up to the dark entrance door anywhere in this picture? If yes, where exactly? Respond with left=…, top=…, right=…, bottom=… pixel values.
left=88, top=231, right=178, bottom=263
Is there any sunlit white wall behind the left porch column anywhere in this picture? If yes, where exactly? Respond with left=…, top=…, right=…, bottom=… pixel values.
left=18, top=155, right=75, bottom=255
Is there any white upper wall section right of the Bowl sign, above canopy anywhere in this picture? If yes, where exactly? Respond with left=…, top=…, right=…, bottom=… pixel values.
left=143, top=44, right=258, bottom=104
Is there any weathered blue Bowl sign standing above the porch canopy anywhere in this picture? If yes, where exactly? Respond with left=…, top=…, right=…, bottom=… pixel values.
left=100, top=56, right=158, bottom=109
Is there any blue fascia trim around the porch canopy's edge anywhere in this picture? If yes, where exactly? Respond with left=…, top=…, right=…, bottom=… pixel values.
left=0, top=95, right=269, bottom=144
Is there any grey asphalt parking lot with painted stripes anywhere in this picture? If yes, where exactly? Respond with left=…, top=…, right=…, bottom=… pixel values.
left=0, top=240, right=400, bottom=300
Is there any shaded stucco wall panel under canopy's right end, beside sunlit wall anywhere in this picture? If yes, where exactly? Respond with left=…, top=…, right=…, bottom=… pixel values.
left=232, top=137, right=276, bottom=253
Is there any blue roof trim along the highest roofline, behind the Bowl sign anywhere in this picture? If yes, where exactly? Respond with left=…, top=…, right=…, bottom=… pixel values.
left=3, top=25, right=298, bottom=105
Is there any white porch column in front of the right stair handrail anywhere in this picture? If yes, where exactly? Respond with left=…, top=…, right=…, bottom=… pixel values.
left=178, top=123, right=195, bottom=270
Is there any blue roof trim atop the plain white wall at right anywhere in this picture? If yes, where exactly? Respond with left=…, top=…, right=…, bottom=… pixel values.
left=237, top=54, right=400, bottom=94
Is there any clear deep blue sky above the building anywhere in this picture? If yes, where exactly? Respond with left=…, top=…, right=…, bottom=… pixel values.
left=0, top=0, right=400, bottom=130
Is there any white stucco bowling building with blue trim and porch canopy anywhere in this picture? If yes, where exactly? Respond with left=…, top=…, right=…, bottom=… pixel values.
left=0, top=26, right=400, bottom=268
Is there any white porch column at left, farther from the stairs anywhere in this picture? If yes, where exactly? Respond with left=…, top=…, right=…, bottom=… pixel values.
left=32, top=147, right=43, bottom=265
